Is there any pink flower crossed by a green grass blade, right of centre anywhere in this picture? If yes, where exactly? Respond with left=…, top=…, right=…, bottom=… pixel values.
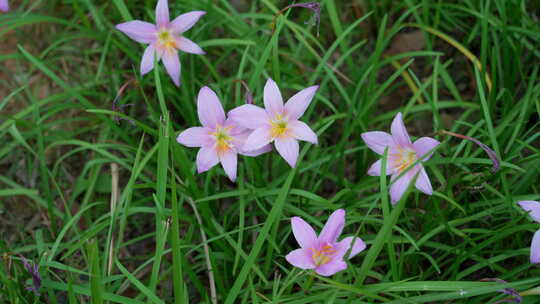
left=362, top=113, right=440, bottom=204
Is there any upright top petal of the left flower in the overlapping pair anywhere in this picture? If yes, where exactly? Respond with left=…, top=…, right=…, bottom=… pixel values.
left=197, top=87, right=225, bottom=129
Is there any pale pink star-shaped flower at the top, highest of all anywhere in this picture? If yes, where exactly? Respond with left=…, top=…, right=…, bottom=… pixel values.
left=116, top=0, right=206, bottom=86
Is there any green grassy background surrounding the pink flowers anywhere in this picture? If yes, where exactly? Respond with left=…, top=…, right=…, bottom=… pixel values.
left=0, top=0, right=540, bottom=304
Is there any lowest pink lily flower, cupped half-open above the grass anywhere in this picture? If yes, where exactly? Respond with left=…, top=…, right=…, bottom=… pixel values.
left=285, top=209, right=366, bottom=276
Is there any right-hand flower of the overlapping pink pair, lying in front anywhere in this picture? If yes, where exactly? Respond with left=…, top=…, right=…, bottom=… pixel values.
left=229, top=79, right=319, bottom=167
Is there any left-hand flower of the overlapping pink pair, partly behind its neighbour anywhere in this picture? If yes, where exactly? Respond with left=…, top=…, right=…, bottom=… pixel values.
left=176, top=87, right=272, bottom=182
